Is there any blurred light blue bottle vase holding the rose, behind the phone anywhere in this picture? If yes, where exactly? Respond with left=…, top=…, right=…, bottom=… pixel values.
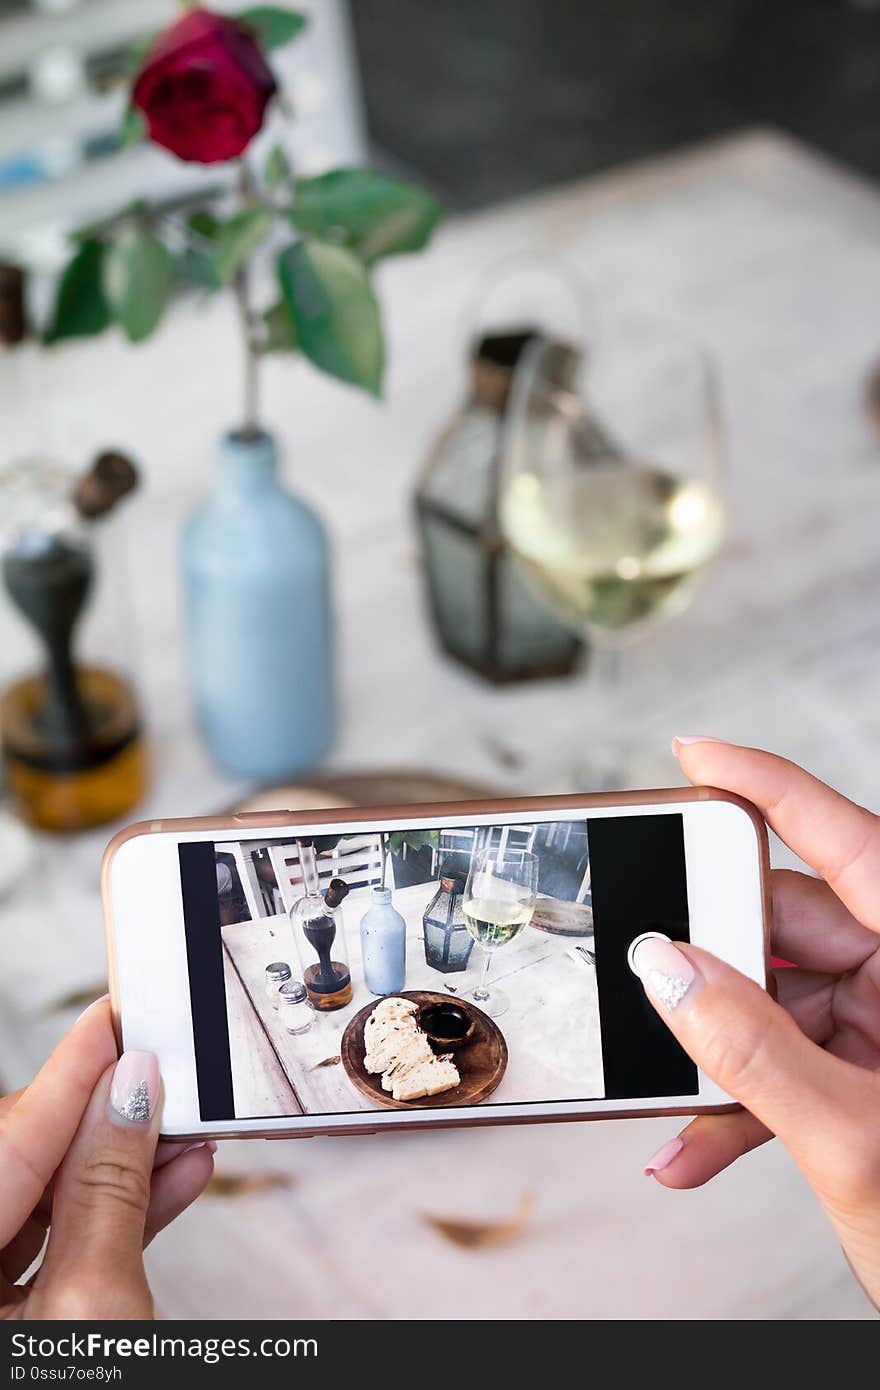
left=182, top=434, right=335, bottom=781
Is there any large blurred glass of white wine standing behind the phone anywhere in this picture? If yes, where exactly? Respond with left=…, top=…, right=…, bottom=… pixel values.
left=499, top=320, right=724, bottom=791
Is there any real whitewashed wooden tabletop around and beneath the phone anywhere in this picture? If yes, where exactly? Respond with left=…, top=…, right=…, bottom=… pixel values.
left=0, top=131, right=880, bottom=1319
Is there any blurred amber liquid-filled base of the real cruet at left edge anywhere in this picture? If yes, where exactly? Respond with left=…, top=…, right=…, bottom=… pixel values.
left=0, top=667, right=149, bottom=831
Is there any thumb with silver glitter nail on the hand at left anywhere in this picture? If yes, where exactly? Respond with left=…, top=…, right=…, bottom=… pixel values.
left=35, top=1052, right=161, bottom=1318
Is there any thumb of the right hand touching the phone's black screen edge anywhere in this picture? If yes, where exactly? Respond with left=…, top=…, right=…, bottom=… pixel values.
left=633, top=937, right=876, bottom=1191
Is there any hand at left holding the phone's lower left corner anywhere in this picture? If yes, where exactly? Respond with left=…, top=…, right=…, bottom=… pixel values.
left=0, top=1001, right=217, bottom=1319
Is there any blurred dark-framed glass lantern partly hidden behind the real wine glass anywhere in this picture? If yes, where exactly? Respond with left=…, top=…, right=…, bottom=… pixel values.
left=414, top=328, right=581, bottom=682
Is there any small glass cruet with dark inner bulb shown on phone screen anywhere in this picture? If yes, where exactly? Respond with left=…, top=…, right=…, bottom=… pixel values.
left=291, top=840, right=352, bottom=1012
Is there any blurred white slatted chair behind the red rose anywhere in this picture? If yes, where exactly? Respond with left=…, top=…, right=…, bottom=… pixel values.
left=0, top=0, right=366, bottom=270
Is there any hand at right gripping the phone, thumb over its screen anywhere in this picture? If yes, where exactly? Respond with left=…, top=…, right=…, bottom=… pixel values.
left=634, top=737, right=880, bottom=1307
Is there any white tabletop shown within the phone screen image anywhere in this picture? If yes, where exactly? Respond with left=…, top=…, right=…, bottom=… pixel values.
left=221, top=880, right=605, bottom=1116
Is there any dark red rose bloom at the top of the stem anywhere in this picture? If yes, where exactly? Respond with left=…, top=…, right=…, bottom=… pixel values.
left=132, top=10, right=275, bottom=164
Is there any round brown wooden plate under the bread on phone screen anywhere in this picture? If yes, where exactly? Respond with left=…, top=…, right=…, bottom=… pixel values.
left=339, top=990, right=507, bottom=1111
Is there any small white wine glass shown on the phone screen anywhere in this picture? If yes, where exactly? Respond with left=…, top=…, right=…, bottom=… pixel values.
left=462, top=845, right=538, bottom=1019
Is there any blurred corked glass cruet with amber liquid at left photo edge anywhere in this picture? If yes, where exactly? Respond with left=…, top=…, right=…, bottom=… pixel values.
left=0, top=453, right=147, bottom=831
